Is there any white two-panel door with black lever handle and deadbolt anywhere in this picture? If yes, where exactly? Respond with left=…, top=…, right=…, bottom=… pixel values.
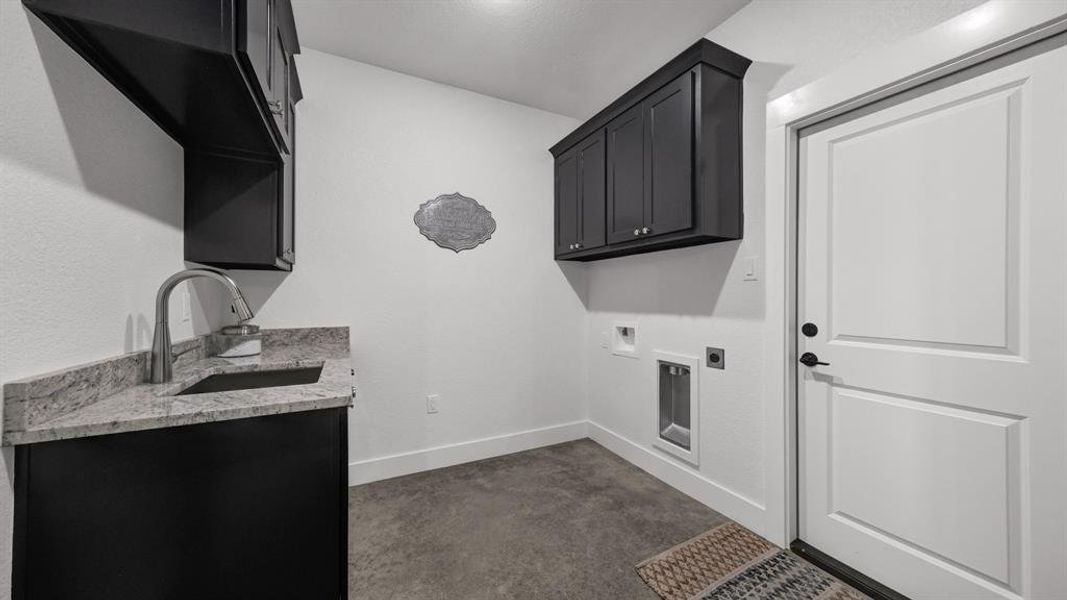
left=797, top=36, right=1067, bottom=600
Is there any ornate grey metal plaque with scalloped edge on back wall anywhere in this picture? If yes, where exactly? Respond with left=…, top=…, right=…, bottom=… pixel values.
left=415, top=192, right=496, bottom=253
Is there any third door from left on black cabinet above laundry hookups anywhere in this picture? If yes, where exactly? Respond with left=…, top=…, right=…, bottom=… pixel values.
left=607, top=105, right=644, bottom=243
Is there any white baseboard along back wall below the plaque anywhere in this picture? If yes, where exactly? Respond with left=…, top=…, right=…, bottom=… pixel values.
left=348, top=421, right=588, bottom=486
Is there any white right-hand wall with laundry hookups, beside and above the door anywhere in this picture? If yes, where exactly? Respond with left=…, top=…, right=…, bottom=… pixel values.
left=587, top=0, right=981, bottom=532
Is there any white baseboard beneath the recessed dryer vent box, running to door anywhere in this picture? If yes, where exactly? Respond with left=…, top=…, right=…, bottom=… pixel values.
left=588, top=421, right=767, bottom=535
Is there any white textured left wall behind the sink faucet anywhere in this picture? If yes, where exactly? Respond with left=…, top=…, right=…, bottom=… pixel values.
left=0, top=0, right=217, bottom=597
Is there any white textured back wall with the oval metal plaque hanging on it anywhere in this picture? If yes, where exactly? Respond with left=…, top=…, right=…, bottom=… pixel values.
left=228, top=49, right=586, bottom=481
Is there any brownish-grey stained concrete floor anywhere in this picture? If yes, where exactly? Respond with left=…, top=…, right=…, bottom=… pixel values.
left=348, top=440, right=727, bottom=600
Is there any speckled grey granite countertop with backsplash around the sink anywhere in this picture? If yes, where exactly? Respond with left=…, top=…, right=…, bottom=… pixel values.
left=3, top=328, right=353, bottom=445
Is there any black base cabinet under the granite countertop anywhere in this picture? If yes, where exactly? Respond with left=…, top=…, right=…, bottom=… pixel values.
left=13, top=408, right=348, bottom=600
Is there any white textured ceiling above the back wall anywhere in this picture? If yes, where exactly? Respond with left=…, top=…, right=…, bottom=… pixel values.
left=292, top=0, right=748, bottom=119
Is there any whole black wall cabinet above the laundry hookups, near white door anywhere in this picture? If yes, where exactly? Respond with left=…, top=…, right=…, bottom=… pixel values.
left=552, top=40, right=751, bottom=260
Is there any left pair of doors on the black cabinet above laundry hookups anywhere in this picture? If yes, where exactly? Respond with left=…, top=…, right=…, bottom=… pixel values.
left=555, top=132, right=605, bottom=256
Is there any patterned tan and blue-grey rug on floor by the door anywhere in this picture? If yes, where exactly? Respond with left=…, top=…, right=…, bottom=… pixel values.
left=637, top=523, right=867, bottom=600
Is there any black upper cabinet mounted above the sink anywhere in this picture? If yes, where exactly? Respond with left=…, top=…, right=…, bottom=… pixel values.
left=23, top=0, right=302, bottom=270
